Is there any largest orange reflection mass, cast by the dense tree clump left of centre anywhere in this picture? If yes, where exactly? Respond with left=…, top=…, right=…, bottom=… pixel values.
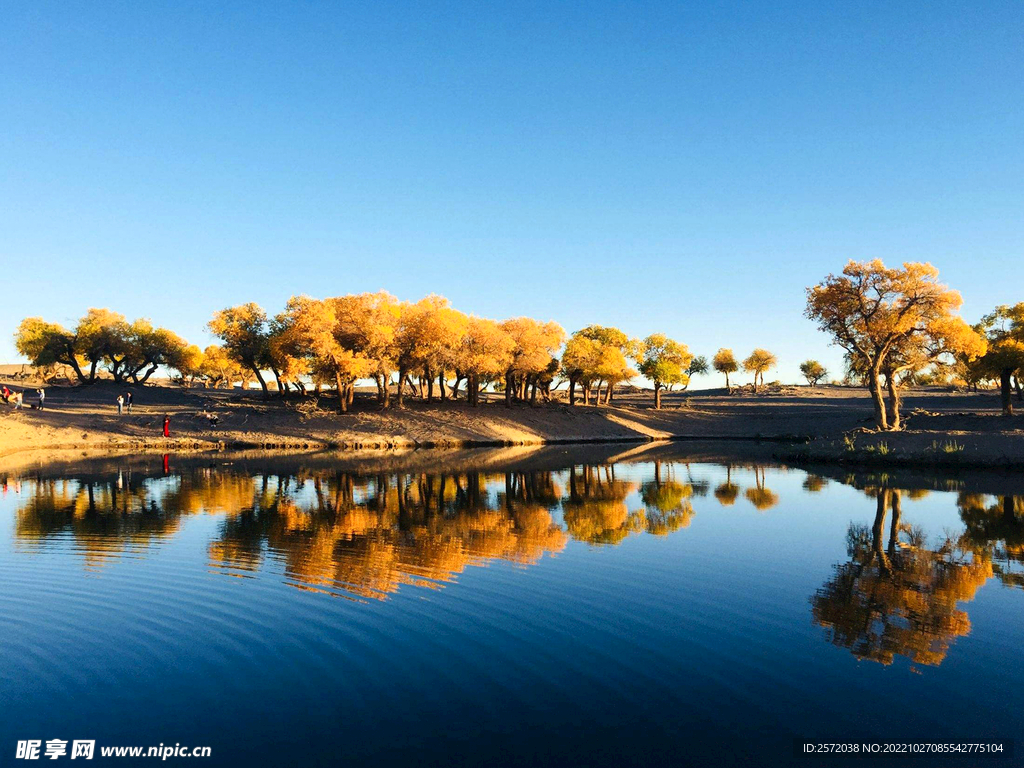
left=209, top=473, right=566, bottom=598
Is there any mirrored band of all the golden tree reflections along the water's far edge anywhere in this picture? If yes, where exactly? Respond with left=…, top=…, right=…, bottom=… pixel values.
left=6, top=461, right=1024, bottom=667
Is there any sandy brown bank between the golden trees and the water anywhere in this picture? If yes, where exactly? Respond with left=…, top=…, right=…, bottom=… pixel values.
left=0, top=381, right=1024, bottom=464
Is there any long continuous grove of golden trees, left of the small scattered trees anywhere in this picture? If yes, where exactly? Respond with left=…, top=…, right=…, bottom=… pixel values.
left=15, top=292, right=708, bottom=413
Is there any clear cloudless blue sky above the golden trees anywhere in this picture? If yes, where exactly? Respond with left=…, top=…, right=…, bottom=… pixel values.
left=0, top=0, right=1024, bottom=386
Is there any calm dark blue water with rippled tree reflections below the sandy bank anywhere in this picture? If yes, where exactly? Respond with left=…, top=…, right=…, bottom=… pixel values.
left=0, top=446, right=1024, bottom=766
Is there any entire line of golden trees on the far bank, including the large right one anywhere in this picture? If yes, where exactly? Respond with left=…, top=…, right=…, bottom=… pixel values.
left=15, top=260, right=1024, bottom=423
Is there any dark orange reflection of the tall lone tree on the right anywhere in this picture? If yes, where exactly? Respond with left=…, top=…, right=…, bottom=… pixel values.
left=811, top=488, right=992, bottom=665
